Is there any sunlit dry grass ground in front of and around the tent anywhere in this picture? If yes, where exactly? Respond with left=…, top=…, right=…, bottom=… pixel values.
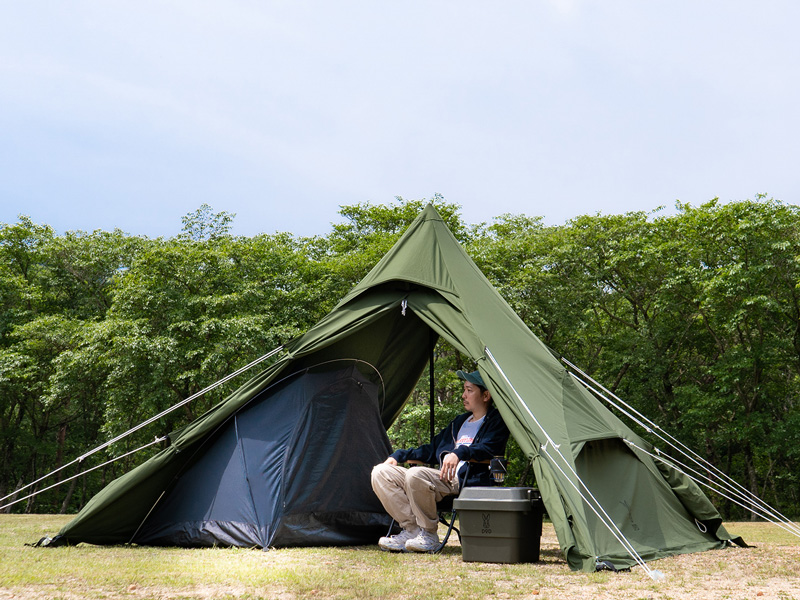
left=0, top=515, right=800, bottom=600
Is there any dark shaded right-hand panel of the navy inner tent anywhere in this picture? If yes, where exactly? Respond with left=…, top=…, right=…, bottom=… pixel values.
left=270, top=360, right=391, bottom=546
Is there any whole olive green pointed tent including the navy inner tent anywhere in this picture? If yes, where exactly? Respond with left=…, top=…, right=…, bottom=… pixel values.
left=48, top=205, right=731, bottom=571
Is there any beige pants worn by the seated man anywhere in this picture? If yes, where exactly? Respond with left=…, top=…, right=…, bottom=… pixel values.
left=372, top=464, right=458, bottom=533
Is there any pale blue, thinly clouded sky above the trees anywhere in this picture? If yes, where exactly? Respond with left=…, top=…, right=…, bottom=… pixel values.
left=0, top=0, right=800, bottom=236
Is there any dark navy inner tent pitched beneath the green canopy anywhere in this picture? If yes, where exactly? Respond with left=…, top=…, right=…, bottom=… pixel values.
left=131, top=361, right=391, bottom=548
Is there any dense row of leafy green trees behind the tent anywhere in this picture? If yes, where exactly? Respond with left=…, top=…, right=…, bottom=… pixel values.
left=0, top=196, right=800, bottom=519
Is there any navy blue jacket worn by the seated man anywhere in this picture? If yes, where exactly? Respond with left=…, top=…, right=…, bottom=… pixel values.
left=392, top=406, right=508, bottom=487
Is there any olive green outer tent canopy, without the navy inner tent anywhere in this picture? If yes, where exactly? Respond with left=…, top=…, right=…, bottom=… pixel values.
left=51, top=205, right=730, bottom=571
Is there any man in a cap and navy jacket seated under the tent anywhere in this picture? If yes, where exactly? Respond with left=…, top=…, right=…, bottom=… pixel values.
left=372, top=371, right=508, bottom=552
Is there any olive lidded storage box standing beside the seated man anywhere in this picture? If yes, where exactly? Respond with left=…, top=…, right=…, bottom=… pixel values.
left=453, top=487, right=544, bottom=563
